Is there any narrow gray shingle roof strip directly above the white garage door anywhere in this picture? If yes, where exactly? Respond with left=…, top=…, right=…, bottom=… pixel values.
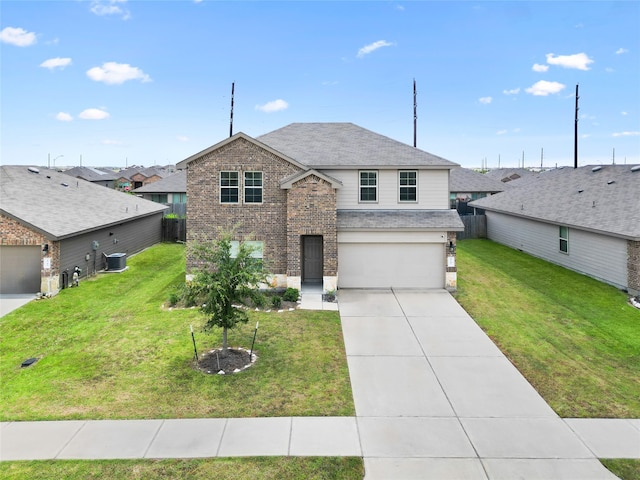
left=337, top=210, right=464, bottom=231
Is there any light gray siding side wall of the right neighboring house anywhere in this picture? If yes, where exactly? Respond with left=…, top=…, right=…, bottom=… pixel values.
left=486, top=211, right=627, bottom=288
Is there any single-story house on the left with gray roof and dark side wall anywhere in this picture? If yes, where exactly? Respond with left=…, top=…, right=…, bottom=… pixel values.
left=0, top=166, right=166, bottom=294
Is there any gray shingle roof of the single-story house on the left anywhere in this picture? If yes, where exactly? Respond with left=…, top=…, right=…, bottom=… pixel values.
left=0, top=165, right=167, bottom=240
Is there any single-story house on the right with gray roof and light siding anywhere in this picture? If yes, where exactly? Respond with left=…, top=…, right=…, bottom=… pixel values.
left=471, top=165, right=640, bottom=295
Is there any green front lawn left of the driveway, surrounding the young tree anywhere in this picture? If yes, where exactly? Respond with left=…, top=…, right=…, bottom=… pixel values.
left=0, top=244, right=355, bottom=421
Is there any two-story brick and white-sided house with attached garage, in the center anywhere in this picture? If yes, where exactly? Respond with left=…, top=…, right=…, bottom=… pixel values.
left=178, top=123, right=464, bottom=291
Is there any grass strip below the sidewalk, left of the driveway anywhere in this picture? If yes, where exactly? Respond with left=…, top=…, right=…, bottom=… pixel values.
left=0, top=457, right=364, bottom=480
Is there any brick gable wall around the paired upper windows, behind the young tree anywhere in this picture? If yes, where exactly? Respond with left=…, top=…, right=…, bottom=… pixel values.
left=187, top=138, right=300, bottom=274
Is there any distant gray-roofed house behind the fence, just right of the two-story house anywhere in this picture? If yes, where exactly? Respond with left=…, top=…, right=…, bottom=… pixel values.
left=449, top=167, right=505, bottom=215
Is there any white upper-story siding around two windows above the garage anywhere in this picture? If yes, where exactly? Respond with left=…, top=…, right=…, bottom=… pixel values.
left=322, top=169, right=449, bottom=210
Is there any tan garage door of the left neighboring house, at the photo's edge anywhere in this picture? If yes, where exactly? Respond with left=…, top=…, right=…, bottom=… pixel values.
left=0, top=245, right=41, bottom=293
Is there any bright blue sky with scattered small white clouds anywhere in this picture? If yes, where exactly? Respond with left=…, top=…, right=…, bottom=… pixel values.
left=0, top=0, right=640, bottom=168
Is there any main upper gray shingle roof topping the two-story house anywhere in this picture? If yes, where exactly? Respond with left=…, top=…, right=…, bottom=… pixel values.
left=256, top=123, right=457, bottom=169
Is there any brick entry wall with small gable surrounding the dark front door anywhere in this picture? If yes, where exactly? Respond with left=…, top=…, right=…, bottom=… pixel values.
left=287, top=175, right=338, bottom=277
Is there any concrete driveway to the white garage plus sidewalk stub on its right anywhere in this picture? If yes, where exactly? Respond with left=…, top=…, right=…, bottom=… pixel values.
left=338, top=290, right=640, bottom=480
